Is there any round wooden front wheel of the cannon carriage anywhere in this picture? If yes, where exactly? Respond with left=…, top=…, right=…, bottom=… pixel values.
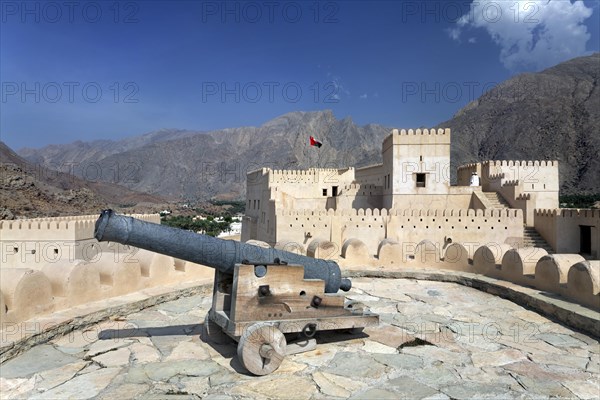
left=238, top=322, right=287, bottom=375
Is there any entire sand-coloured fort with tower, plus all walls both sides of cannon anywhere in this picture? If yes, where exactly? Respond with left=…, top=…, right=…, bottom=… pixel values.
left=0, top=129, right=600, bottom=394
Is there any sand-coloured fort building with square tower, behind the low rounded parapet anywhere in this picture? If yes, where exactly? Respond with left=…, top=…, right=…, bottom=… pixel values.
left=242, top=129, right=600, bottom=260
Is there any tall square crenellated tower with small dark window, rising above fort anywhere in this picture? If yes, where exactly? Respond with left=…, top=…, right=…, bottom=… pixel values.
left=382, top=129, right=450, bottom=208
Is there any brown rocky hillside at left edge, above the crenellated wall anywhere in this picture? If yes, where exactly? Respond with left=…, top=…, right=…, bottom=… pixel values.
left=0, top=142, right=166, bottom=219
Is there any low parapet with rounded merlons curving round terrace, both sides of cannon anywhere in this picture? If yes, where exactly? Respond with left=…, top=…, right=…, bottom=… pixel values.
left=0, top=214, right=600, bottom=336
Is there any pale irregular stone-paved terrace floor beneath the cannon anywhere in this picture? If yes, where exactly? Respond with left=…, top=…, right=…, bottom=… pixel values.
left=0, top=278, right=600, bottom=399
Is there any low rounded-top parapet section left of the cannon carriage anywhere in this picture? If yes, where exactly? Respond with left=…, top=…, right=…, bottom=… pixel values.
left=0, top=250, right=214, bottom=330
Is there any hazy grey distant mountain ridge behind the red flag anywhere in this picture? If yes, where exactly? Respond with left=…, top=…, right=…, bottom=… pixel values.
left=20, top=111, right=390, bottom=201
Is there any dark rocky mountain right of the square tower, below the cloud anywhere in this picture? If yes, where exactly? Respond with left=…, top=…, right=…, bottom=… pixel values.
left=439, top=53, right=600, bottom=194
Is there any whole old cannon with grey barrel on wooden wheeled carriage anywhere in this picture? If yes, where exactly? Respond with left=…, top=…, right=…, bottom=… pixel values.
left=94, top=210, right=379, bottom=375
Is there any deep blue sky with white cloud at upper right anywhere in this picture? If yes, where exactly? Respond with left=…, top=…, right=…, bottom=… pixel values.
left=0, top=0, right=600, bottom=149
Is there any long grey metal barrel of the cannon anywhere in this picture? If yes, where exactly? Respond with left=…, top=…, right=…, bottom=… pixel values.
left=94, top=210, right=352, bottom=293
